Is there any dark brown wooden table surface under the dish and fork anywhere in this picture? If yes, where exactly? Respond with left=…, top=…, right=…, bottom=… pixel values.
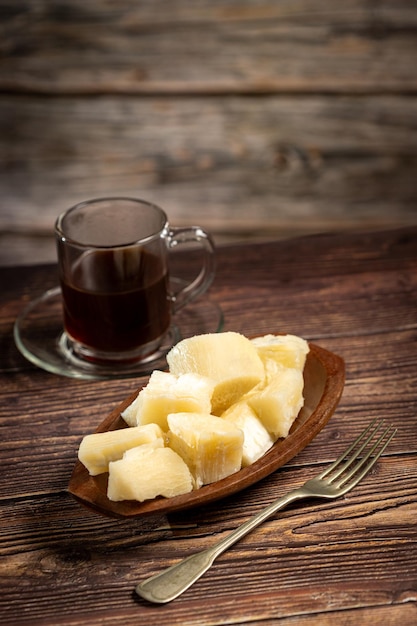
left=0, top=228, right=417, bottom=626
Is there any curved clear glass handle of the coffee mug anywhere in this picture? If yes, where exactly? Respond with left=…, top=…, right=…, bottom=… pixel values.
left=166, top=226, right=216, bottom=313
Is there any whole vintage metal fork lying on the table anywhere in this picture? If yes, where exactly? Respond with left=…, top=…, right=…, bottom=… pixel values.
left=136, top=420, right=397, bottom=604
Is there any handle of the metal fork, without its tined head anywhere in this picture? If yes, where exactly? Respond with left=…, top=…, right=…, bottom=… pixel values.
left=136, top=487, right=311, bottom=604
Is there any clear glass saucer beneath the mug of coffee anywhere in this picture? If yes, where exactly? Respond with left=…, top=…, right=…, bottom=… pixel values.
left=13, top=279, right=223, bottom=380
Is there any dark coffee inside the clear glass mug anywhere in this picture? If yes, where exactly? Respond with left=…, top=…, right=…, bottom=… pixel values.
left=61, top=249, right=170, bottom=353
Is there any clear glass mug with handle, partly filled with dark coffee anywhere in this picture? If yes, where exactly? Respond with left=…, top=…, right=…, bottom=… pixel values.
left=55, top=198, right=215, bottom=364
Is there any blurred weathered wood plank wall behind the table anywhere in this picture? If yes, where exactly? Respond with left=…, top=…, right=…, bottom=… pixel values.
left=0, top=0, right=417, bottom=265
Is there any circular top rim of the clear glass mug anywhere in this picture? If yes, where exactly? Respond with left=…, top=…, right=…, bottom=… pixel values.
left=54, top=196, right=169, bottom=250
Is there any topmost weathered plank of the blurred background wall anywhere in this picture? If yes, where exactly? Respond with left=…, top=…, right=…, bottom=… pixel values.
left=0, top=0, right=417, bottom=95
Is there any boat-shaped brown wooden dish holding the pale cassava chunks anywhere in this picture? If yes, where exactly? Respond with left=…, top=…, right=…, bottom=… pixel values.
left=69, top=344, right=345, bottom=518
